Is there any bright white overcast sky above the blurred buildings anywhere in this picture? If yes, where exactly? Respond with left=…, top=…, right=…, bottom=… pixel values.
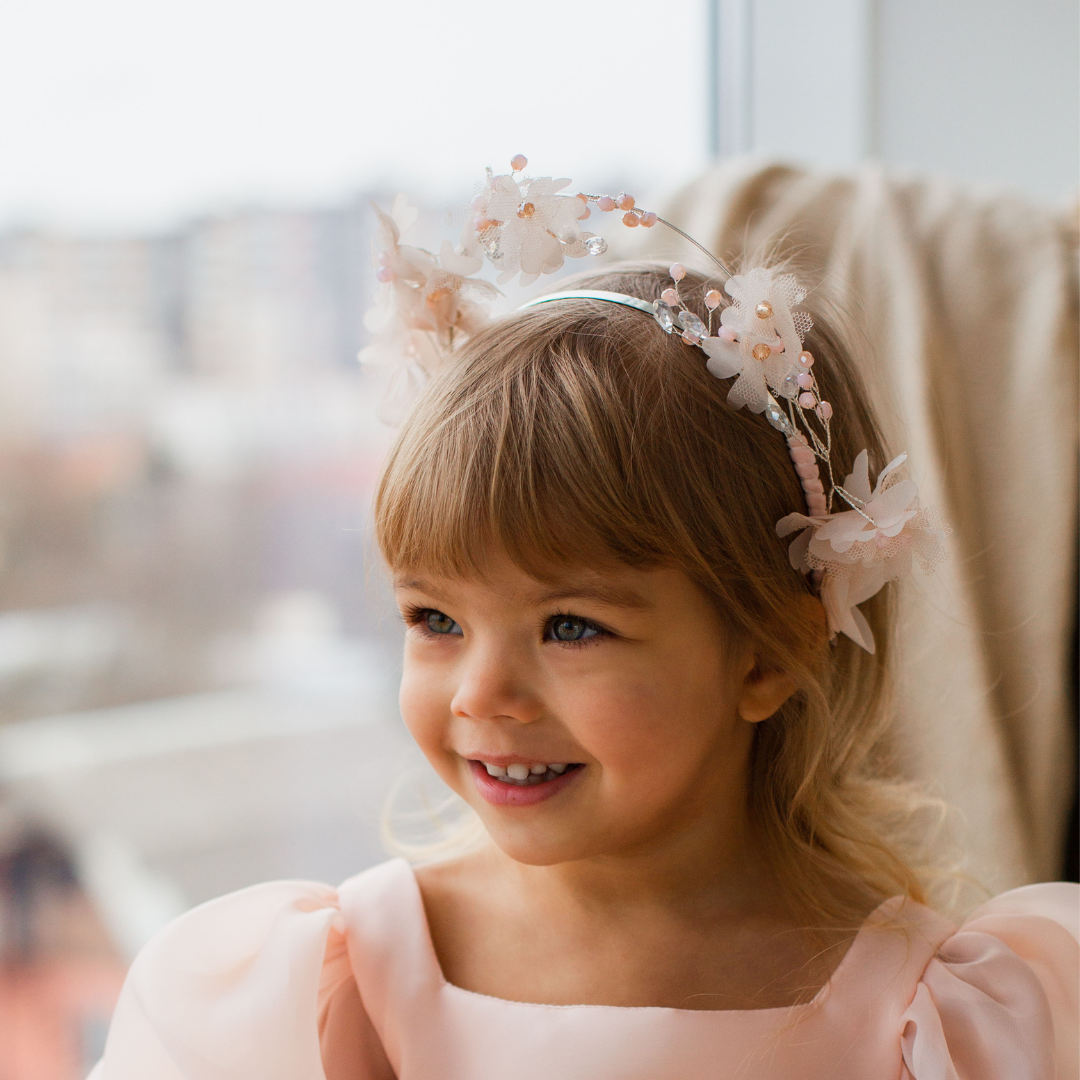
left=0, top=0, right=707, bottom=230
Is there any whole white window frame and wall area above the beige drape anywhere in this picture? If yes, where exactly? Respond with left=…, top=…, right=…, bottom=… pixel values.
left=715, top=0, right=1080, bottom=200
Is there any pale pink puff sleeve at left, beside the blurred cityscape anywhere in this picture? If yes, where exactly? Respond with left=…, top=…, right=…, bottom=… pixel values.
left=90, top=881, right=392, bottom=1080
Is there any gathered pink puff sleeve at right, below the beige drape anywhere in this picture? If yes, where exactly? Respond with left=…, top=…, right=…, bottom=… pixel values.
left=901, top=882, right=1080, bottom=1080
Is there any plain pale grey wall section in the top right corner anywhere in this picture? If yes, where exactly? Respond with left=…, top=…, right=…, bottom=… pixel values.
left=876, top=0, right=1080, bottom=199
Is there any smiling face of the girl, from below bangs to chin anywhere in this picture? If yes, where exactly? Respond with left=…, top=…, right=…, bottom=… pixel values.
left=395, top=557, right=793, bottom=865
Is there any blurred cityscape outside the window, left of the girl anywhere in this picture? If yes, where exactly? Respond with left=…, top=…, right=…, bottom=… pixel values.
left=0, top=199, right=425, bottom=1080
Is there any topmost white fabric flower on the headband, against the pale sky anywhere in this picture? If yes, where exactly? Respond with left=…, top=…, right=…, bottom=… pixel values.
left=473, top=175, right=593, bottom=285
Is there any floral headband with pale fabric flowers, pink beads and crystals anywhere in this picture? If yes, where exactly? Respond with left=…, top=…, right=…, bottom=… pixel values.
left=361, top=154, right=948, bottom=652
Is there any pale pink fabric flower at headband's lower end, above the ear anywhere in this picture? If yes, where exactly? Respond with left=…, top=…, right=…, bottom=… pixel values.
left=777, top=450, right=947, bottom=652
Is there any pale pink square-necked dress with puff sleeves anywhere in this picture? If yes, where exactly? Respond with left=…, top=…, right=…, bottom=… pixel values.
left=91, top=860, right=1080, bottom=1080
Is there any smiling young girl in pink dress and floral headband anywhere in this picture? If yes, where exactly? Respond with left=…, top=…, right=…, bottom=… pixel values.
left=88, top=159, right=1080, bottom=1080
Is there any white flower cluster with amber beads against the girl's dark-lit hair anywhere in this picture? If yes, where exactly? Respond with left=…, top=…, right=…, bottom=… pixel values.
left=701, top=267, right=812, bottom=413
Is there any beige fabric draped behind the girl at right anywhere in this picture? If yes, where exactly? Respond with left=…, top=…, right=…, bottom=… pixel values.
left=635, top=161, right=1078, bottom=891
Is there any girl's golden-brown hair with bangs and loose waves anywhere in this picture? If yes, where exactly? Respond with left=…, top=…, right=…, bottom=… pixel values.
left=375, top=264, right=946, bottom=926
